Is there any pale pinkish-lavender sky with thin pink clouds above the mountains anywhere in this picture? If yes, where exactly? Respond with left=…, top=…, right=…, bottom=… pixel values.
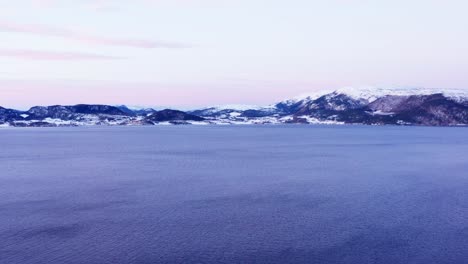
left=0, top=0, right=468, bottom=108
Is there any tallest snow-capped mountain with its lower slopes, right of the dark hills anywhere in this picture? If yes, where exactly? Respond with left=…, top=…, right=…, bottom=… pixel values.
left=191, top=87, right=468, bottom=125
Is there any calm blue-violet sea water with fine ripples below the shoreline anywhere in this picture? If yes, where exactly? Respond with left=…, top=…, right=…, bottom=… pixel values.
left=0, top=125, right=468, bottom=264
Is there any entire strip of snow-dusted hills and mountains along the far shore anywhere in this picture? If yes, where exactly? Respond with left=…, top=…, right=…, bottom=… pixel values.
left=0, top=88, right=468, bottom=127
